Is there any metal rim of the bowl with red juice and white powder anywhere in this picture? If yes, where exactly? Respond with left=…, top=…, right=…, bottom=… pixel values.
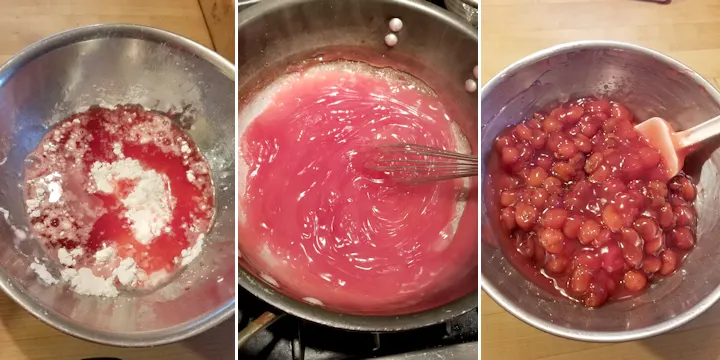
left=0, top=24, right=235, bottom=347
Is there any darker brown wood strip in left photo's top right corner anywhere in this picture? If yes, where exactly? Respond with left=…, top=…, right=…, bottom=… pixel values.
left=199, top=0, right=237, bottom=63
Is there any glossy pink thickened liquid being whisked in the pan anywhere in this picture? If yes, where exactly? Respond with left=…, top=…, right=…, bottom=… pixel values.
left=239, top=64, right=477, bottom=313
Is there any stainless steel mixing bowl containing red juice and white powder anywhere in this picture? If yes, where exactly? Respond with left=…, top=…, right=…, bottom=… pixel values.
left=0, top=25, right=236, bottom=346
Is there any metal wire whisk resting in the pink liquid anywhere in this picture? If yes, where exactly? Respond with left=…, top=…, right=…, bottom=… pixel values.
left=366, top=144, right=478, bottom=185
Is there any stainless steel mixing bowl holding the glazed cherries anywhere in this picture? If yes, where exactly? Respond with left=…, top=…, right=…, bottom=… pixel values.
left=481, top=41, right=720, bottom=342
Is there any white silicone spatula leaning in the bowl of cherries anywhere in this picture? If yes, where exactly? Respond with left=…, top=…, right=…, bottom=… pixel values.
left=635, top=115, right=720, bottom=177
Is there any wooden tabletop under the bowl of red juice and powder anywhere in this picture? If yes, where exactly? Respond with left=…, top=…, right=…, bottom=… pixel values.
left=0, top=0, right=235, bottom=360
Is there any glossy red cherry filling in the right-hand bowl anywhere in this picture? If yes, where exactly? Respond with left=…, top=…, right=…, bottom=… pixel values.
left=490, top=98, right=697, bottom=307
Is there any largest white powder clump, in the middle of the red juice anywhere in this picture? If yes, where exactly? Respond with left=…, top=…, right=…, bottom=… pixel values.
left=90, top=158, right=174, bottom=245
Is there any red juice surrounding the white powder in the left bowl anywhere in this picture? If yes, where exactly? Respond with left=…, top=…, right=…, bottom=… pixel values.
left=25, top=106, right=214, bottom=286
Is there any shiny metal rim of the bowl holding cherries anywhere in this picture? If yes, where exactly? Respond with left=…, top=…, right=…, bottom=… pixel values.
left=480, top=40, right=720, bottom=342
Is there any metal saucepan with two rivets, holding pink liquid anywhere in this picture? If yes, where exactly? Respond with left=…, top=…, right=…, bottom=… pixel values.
left=237, top=0, right=478, bottom=343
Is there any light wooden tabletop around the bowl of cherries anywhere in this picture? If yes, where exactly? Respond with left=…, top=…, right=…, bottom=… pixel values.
left=481, top=0, right=720, bottom=360
